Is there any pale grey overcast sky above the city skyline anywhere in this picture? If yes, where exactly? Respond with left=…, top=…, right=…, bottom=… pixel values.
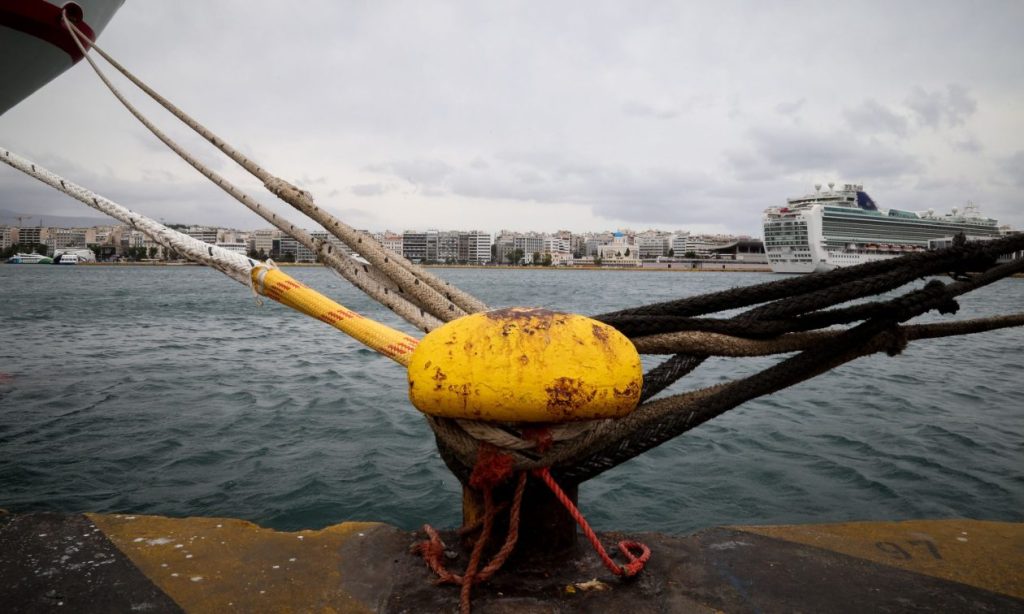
left=0, top=0, right=1024, bottom=235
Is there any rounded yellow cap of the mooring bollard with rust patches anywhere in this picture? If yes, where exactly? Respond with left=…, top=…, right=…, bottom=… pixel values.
left=409, top=307, right=643, bottom=423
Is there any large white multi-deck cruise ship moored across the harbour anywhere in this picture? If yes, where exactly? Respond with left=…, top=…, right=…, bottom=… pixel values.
left=764, top=183, right=999, bottom=273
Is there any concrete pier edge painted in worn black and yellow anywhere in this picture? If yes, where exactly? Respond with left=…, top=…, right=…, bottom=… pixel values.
left=0, top=513, right=1024, bottom=613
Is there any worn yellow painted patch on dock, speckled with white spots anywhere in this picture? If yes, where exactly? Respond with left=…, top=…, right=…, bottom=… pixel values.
left=87, top=514, right=386, bottom=613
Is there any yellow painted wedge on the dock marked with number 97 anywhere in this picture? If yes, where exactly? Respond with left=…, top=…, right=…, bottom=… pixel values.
left=732, top=520, right=1024, bottom=599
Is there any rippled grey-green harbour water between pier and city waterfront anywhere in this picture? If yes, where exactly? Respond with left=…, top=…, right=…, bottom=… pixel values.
left=0, top=265, right=1024, bottom=532
